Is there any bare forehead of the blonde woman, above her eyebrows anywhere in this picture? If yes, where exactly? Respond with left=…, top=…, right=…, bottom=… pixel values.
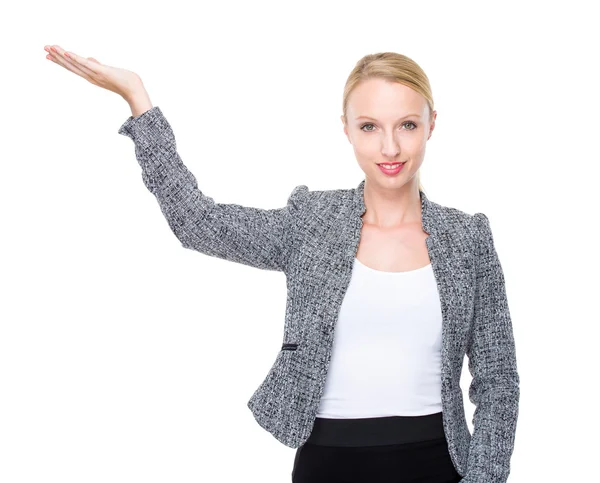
left=347, top=79, right=427, bottom=118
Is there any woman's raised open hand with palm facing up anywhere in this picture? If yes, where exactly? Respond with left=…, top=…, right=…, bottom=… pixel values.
left=44, top=45, right=144, bottom=102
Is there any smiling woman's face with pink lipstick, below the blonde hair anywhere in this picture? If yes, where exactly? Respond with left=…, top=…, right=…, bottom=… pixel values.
left=342, top=78, right=437, bottom=188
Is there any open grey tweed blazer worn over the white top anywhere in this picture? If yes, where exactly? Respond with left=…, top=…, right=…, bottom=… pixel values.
left=118, top=106, right=520, bottom=483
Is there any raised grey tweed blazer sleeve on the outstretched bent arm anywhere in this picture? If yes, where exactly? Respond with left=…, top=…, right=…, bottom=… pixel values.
left=118, top=106, right=308, bottom=271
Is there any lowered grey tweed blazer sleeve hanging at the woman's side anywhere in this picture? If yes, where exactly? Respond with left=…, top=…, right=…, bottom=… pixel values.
left=461, top=213, right=520, bottom=483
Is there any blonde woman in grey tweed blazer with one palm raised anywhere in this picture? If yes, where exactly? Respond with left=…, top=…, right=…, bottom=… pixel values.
left=46, top=46, right=520, bottom=483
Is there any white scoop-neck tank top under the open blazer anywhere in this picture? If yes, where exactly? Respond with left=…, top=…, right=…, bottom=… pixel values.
left=317, top=258, right=442, bottom=418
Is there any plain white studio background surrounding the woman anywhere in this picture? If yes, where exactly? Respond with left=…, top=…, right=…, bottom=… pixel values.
left=0, top=0, right=600, bottom=483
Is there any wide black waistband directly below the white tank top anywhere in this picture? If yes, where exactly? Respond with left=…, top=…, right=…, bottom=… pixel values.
left=306, top=412, right=445, bottom=446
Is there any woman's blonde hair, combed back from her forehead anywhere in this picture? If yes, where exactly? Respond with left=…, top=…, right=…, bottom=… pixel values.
left=342, top=52, right=434, bottom=195
